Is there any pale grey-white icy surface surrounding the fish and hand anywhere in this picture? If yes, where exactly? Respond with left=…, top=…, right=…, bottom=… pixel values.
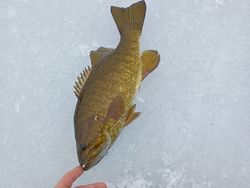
left=0, top=0, right=250, bottom=188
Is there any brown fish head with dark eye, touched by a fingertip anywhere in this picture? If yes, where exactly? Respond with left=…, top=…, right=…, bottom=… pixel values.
left=77, top=116, right=111, bottom=170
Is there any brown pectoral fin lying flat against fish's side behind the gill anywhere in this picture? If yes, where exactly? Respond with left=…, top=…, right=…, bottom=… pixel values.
left=107, top=95, right=124, bottom=121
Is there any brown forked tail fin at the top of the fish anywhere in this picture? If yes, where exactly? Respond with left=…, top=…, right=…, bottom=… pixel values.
left=111, top=1, right=146, bottom=36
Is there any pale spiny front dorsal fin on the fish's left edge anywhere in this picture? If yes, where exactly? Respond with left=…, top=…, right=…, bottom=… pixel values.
left=74, top=66, right=92, bottom=97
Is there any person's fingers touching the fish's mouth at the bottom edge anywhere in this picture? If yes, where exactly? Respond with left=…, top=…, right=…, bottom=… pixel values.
left=55, top=166, right=107, bottom=188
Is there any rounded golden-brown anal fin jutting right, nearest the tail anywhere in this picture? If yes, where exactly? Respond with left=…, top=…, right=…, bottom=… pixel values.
left=141, top=50, right=160, bottom=80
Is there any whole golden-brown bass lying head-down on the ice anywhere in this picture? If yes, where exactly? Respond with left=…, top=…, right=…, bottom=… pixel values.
left=74, top=1, right=160, bottom=171
